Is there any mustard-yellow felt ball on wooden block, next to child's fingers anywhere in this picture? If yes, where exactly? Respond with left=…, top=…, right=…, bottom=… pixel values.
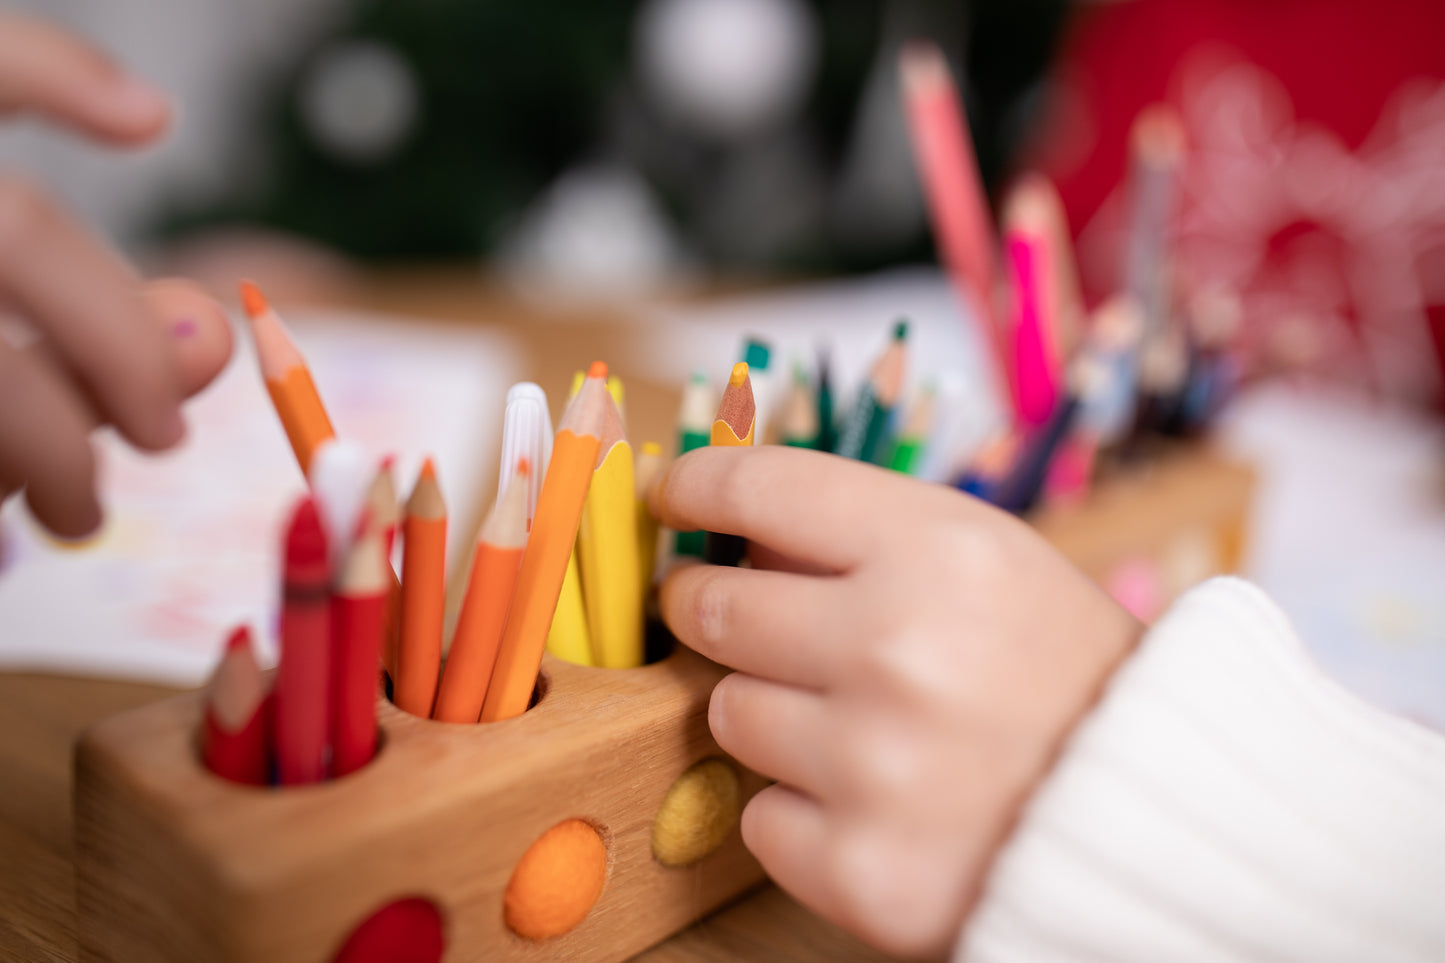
left=652, top=759, right=743, bottom=866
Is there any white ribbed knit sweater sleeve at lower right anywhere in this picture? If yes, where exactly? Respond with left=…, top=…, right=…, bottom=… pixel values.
left=955, top=578, right=1445, bottom=963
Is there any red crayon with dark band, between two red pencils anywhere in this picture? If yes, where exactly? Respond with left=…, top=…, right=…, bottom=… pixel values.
left=276, top=497, right=331, bottom=785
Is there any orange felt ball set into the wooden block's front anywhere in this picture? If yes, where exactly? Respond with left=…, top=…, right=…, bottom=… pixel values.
left=503, top=820, right=607, bottom=940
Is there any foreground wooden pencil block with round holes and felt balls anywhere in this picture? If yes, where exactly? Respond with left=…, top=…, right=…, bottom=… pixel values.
left=75, top=646, right=766, bottom=963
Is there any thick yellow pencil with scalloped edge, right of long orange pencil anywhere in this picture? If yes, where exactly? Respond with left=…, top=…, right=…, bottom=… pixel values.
left=577, top=398, right=642, bottom=668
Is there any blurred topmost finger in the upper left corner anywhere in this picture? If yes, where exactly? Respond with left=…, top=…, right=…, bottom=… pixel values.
left=0, top=12, right=171, bottom=145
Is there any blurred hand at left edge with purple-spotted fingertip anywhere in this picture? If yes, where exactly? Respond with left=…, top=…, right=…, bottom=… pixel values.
left=0, top=12, right=231, bottom=536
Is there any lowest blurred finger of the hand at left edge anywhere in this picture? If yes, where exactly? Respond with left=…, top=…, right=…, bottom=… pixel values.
left=0, top=341, right=101, bottom=538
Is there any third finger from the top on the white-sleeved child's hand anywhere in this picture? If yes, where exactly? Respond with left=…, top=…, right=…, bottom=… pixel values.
left=708, top=672, right=832, bottom=798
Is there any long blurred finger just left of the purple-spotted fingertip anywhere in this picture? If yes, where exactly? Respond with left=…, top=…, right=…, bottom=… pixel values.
left=0, top=175, right=185, bottom=450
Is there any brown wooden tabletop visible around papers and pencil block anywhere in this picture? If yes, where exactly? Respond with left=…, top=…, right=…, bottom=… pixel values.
left=0, top=269, right=886, bottom=963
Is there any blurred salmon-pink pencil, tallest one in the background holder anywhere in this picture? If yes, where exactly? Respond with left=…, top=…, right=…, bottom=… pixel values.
left=899, top=40, right=1013, bottom=409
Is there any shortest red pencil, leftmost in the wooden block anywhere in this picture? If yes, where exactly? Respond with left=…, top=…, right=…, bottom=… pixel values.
left=201, top=625, right=270, bottom=785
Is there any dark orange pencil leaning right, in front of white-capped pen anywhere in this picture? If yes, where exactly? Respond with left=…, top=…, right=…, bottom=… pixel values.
left=432, top=458, right=532, bottom=723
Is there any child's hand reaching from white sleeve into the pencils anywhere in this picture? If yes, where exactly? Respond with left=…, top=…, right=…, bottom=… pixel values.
left=655, top=445, right=1143, bottom=956
